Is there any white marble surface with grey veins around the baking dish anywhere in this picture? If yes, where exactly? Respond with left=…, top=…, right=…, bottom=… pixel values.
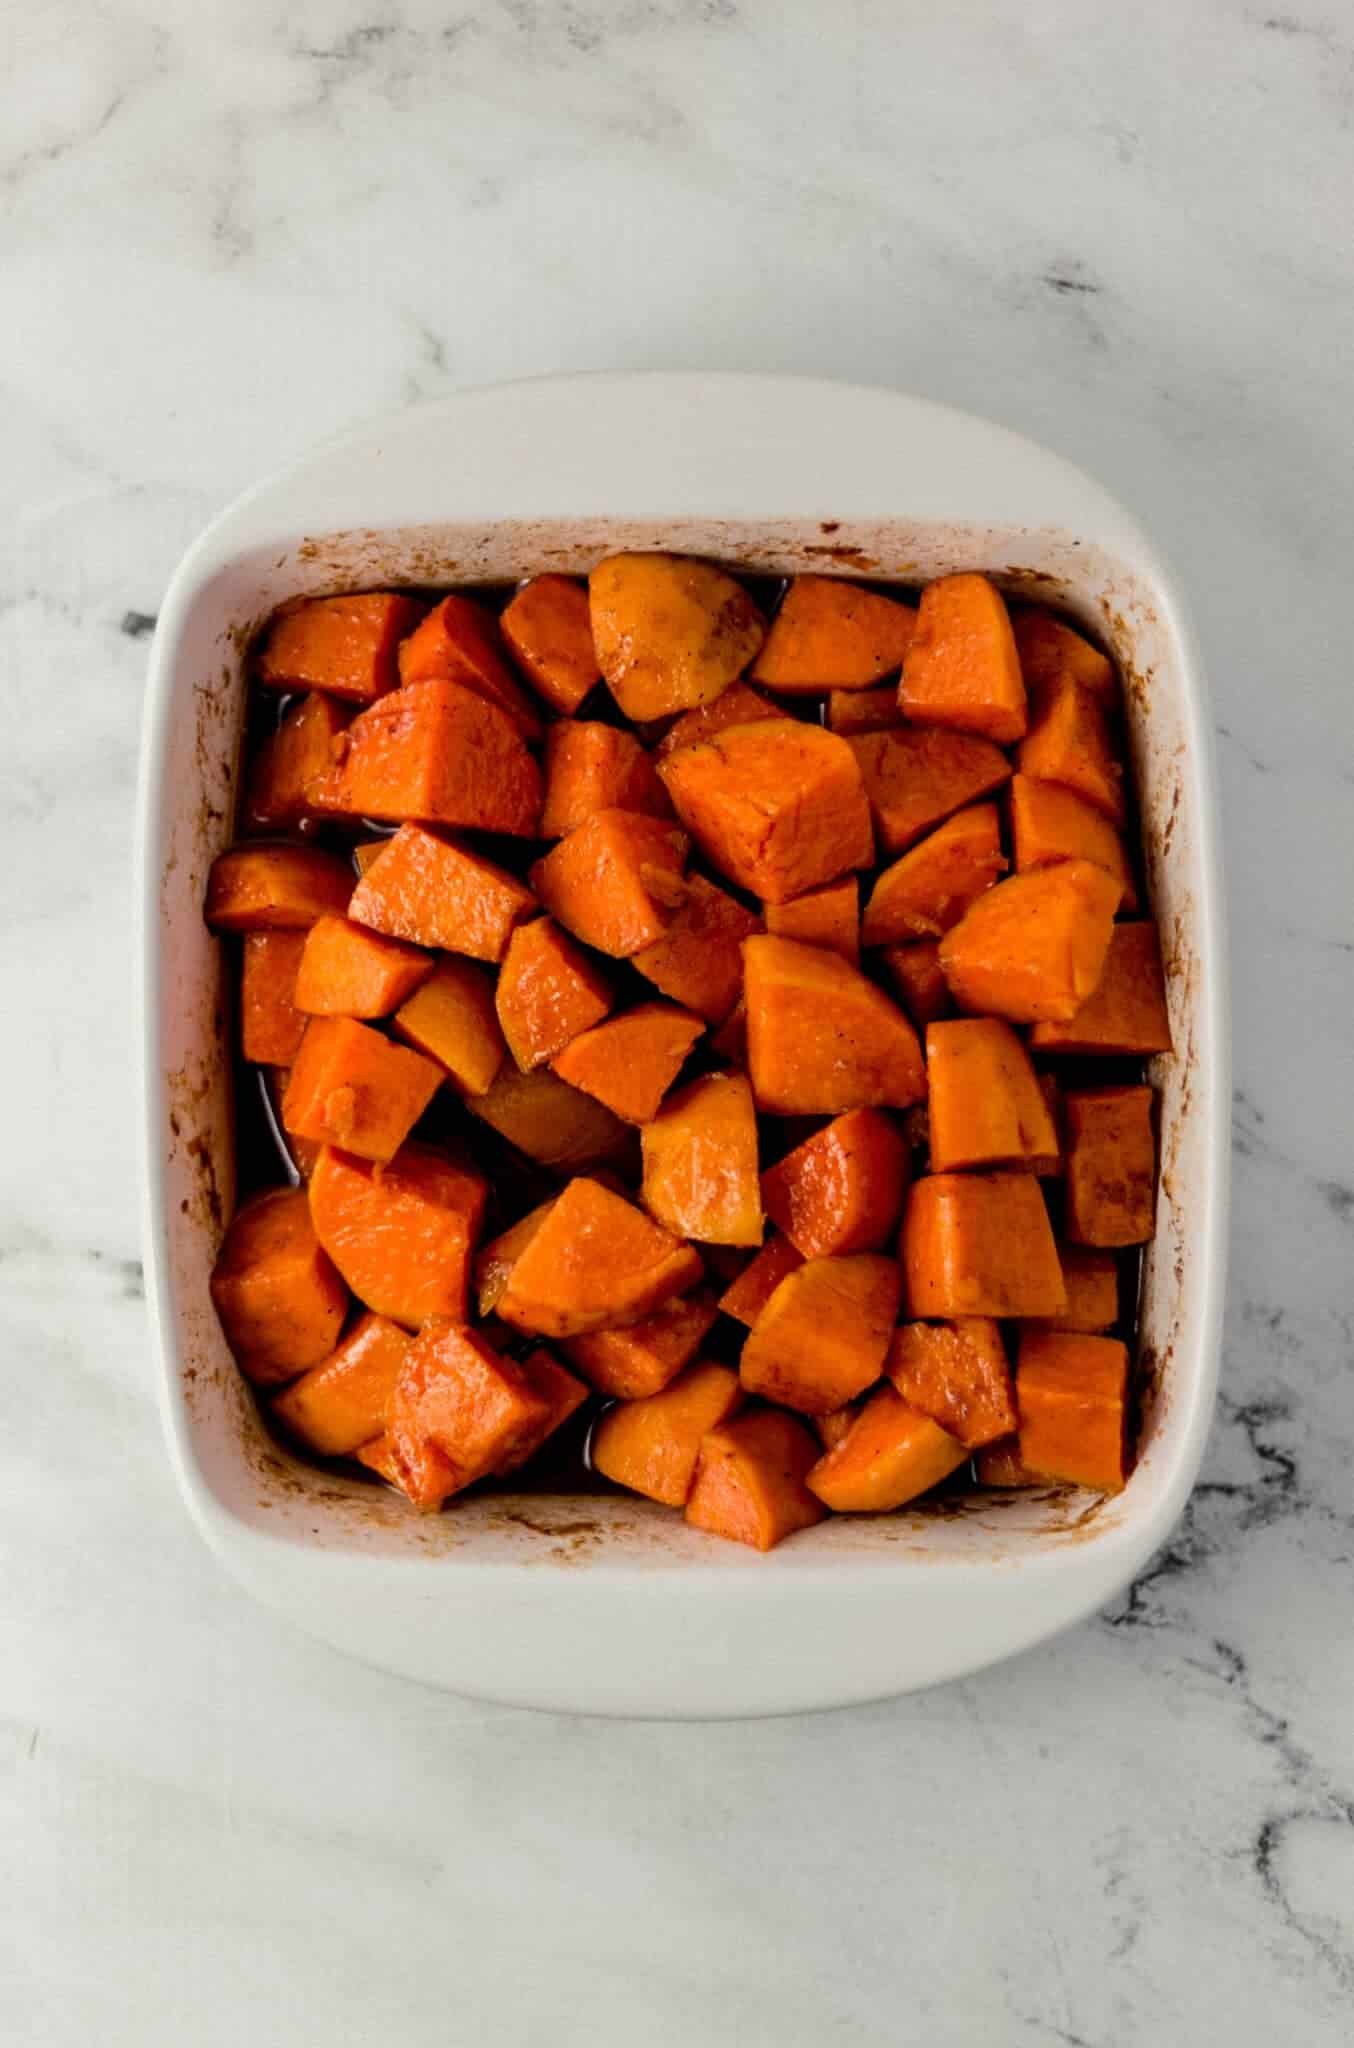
left=0, top=0, right=1354, bottom=2048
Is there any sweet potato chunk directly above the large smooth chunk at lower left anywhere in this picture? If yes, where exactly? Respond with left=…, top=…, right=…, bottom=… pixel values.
left=283, top=1018, right=442, bottom=1159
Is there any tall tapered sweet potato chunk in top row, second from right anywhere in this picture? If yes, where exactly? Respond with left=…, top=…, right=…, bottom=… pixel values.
left=897, top=575, right=1026, bottom=745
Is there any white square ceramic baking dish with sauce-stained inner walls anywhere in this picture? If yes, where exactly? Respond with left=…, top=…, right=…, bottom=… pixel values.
left=139, top=375, right=1229, bottom=1716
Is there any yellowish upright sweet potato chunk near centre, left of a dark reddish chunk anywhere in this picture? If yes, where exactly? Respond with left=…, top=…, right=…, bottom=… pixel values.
left=639, top=1073, right=762, bottom=1245
